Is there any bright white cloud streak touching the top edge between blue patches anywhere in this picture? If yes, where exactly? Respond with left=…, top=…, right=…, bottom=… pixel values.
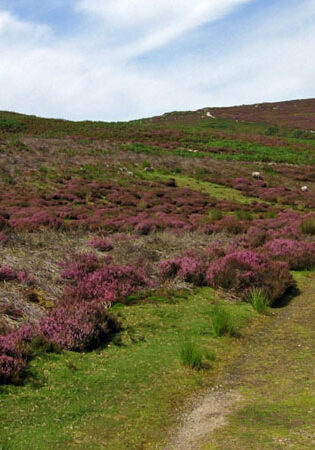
left=77, top=0, right=252, bottom=57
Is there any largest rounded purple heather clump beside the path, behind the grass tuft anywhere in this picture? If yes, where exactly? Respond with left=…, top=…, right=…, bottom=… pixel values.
left=206, top=250, right=294, bottom=302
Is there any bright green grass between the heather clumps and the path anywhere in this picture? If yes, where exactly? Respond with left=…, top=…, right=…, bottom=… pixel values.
left=0, top=288, right=252, bottom=450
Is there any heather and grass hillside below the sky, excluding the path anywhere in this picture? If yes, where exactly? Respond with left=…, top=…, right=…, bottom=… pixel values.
left=0, top=99, right=315, bottom=449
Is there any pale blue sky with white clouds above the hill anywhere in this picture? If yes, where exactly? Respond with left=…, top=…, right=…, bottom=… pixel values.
left=0, top=0, right=315, bottom=121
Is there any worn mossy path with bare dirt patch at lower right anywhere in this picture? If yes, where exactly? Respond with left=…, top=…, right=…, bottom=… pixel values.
left=166, top=274, right=315, bottom=450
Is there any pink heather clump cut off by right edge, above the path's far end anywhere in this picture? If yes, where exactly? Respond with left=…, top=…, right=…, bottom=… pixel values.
left=264, top=239, right=315, bottom=270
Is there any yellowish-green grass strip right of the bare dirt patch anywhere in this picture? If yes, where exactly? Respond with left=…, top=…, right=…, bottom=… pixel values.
left=203, top=272, right=315, bottom=450
